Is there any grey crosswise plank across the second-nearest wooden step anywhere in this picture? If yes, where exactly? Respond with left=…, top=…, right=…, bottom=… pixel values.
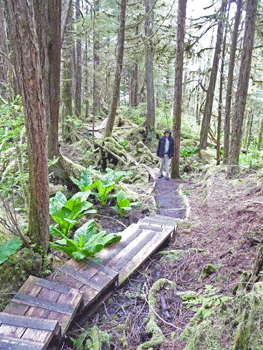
left=12, top=293, right=74, bottom=315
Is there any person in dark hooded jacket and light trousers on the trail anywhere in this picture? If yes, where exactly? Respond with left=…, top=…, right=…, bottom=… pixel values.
left=157, top=129, right=174, bottom=180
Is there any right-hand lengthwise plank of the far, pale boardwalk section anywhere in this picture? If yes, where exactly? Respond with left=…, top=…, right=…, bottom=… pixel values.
left=119, top=229, right=171, bottom=284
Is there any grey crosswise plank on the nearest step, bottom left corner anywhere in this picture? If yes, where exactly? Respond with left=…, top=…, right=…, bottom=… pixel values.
left=0, top=312, right=58, bottom=332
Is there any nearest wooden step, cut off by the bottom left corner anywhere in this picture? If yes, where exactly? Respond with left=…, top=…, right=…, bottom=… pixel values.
left=0, top=312, right=61, bottom=350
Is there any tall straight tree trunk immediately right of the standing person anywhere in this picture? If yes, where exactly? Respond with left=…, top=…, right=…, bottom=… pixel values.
left=172, top=0, right=187, bottom=179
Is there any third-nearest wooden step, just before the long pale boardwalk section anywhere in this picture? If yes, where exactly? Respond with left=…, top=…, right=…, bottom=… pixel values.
left=51, top=259, right=118, bottom=311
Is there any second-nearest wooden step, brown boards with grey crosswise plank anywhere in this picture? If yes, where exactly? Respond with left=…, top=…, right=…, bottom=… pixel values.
left=5, top=276, right=83, bottom=334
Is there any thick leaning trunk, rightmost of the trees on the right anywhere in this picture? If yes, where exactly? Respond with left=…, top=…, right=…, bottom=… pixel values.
left=229, top=0, right=257, bottom=174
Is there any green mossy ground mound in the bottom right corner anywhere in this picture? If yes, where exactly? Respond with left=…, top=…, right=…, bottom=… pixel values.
left=181, top=282, right=263, bottom=350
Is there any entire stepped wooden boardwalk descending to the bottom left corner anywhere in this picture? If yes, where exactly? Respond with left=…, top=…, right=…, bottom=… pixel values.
left=0, top=215, right=183, bottom=350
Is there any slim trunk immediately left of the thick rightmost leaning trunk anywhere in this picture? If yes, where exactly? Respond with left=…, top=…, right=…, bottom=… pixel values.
left=223, top=0, right=242, bottom=164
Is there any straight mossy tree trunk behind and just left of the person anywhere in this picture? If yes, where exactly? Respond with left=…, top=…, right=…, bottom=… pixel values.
left=144, top=0, right=155, bottom=134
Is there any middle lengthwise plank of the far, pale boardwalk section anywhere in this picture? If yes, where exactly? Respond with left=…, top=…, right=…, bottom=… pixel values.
left=107, top=230, right=157, bottom=272
